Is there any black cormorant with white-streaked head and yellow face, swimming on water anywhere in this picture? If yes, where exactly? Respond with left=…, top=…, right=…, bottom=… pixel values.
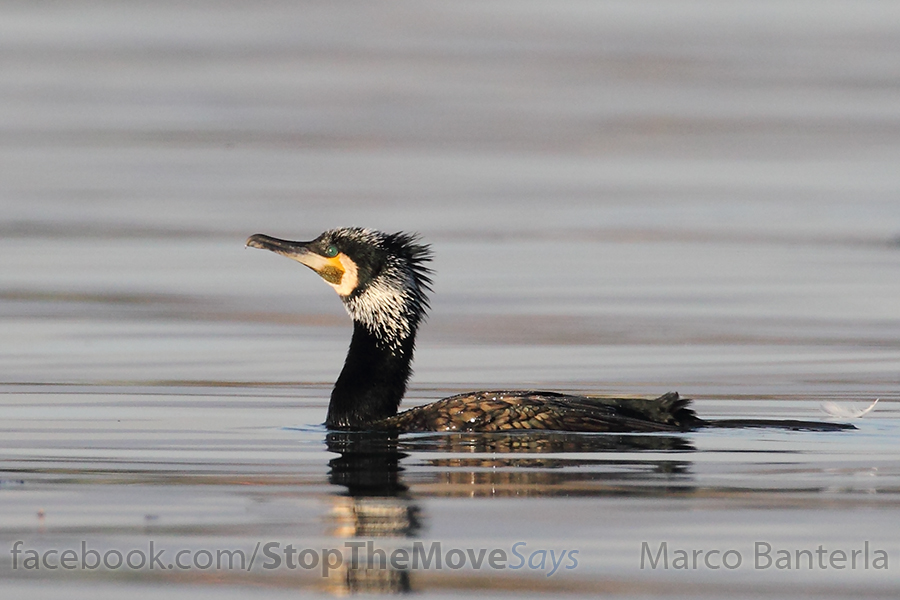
left=246, top=227, right=854, bottom=433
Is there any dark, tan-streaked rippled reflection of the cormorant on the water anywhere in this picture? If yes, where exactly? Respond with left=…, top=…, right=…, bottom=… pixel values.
left=326, top=432, right=694, bottom=594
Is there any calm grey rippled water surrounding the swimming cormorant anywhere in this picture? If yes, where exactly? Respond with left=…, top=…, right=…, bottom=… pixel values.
left=0, top=0, right=900, bottom=598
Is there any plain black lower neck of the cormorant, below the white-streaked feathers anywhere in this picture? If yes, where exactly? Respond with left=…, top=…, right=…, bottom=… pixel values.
left=325, top=321, right=416, bottom=429
